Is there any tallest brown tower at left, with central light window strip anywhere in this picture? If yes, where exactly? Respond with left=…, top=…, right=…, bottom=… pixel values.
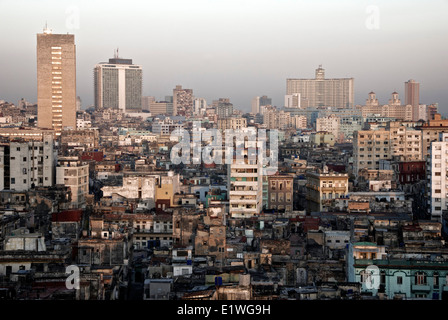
left=37, top=29, right=76, bottom=135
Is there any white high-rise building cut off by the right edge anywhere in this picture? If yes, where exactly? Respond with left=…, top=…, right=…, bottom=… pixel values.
left=427, top=133, right=448, bottom=222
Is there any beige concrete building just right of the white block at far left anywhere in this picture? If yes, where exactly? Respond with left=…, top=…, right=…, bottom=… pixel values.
left=56, top=157, right=89, bottom=209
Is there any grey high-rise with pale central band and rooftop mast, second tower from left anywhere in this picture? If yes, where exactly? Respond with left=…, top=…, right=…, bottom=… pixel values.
left=94, top=55, right=143, bottom=113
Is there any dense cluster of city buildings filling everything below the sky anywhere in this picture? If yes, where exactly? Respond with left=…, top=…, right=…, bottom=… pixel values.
left=0, top=29, right=448, bottom=300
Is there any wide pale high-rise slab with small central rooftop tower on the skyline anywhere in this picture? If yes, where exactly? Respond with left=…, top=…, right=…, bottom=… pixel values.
left=286, top=66, right=355, bottom=108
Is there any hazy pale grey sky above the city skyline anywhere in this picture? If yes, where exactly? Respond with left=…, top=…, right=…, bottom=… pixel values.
left=0, top=0, right=448, bottom=114
